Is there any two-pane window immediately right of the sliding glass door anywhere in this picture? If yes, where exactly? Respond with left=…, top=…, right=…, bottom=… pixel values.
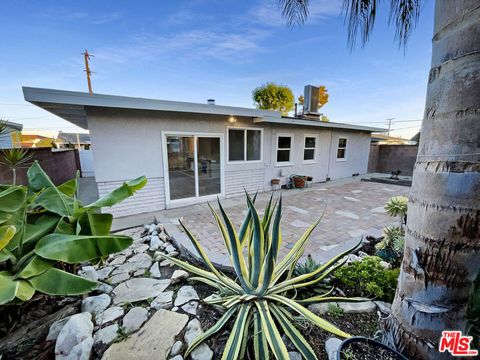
left=228, top=128, right=262, bottom=162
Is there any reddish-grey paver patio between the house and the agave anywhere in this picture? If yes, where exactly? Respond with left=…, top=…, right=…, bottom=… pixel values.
left=113, top=178, right=410, bottom=266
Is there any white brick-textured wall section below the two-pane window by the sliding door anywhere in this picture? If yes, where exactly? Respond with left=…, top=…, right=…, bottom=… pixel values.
left=225, top=168, right=265, bottom=197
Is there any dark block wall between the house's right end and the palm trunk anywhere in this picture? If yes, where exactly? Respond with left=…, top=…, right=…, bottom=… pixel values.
left=368, top=145, right=418, bottom=176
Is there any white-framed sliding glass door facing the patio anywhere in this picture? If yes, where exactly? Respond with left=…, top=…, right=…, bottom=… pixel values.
left=164, top=134, right=222, bottom=205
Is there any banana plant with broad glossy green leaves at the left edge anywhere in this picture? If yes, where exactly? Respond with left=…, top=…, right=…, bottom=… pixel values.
left=0, top=162, right=147, bottom=305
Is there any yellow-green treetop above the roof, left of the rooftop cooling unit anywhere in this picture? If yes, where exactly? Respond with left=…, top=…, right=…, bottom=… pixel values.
left=252, top=83, right=295, bottom=115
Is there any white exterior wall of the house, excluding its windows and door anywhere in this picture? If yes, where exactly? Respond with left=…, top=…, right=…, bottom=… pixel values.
left=88, top=109, right=370, bottom=216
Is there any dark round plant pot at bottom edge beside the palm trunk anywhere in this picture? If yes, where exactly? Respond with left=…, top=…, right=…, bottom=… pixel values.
left=337, top=336, right=408, bottom=360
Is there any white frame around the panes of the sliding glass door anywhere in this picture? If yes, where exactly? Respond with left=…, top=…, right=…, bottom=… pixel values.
left=162, top=130, right=225, bottom=209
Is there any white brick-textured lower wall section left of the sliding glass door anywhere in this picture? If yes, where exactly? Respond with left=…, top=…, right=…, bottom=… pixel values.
left=97, top=178, right=165, bottom=217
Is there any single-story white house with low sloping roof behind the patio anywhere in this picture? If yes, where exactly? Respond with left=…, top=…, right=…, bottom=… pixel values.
left=23, top=87, right=382, bottom=216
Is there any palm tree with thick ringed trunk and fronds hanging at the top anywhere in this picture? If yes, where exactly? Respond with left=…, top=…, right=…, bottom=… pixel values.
left=279, top=0, right=480, bottom=359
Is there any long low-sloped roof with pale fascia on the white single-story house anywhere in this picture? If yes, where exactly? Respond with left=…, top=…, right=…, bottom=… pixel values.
left=23, top=86, right=385, bottom=132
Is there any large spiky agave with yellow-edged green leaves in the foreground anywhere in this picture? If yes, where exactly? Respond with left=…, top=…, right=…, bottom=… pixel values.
left=163, top=194, right=364, bottom=360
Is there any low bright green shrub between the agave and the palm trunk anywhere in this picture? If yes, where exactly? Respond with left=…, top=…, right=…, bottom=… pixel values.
left=334, top=256, right=400, bottom=302
